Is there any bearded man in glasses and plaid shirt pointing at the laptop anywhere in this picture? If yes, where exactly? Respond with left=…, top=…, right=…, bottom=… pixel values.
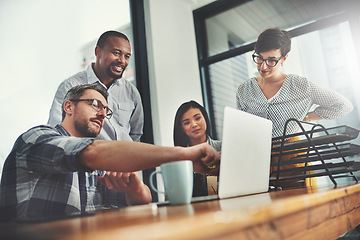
left=0, top=83, right=220, bottom=221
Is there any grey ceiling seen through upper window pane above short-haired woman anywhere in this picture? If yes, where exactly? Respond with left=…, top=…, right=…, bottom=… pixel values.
left=204, top=0, right=360, bottom=46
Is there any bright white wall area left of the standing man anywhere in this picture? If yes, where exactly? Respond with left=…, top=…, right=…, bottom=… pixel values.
left=0, top=0, right=130, bottom=176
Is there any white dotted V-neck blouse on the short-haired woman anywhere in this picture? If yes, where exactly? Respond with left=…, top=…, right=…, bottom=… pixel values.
left=236, top=74, right=353, bottom=137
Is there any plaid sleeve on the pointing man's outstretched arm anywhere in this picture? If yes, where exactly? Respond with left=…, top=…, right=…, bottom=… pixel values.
left=16, top=126, right=94, bottom=173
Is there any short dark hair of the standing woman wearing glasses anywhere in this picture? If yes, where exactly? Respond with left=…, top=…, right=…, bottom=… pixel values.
left=254, top=28, right=291, bottom=57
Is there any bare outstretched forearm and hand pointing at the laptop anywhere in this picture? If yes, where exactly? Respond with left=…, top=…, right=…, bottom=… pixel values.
left=79, top=140, right=220, bottom=174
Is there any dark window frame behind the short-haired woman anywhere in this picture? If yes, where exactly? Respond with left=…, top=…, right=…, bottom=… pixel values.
left=193, top=0, right=360, bottom=139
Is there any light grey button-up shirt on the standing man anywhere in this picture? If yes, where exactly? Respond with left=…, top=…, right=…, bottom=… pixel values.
left=48, top=63, right=144, bottom=141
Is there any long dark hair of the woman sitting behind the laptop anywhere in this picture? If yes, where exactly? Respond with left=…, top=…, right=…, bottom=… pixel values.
left=173, top=100, right=210, bottom=147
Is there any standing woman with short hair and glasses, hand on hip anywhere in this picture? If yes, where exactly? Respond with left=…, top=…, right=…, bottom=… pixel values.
left=236, top=28, right=353, bottom=186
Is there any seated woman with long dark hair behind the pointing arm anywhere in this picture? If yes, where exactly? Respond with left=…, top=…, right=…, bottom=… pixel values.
left=173, top=101, right=221, bottom=197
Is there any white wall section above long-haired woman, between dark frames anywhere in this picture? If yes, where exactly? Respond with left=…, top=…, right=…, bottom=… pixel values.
left=144, top=0, right=203, bottom=146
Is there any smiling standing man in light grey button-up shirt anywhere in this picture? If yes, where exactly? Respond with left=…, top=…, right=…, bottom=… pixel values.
left=48, top=31, right=144, bottom=141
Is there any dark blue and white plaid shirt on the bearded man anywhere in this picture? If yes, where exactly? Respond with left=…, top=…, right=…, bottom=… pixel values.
left=0, top=125, right=126, bottom=221
